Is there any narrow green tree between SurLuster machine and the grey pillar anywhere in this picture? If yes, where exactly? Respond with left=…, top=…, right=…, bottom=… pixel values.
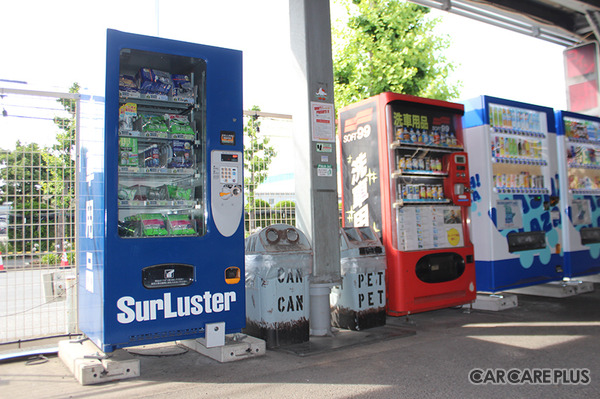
left=244, top=105, right=277, bottom=231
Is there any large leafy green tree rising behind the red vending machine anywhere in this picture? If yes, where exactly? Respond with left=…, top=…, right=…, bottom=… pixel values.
left=333, top=0, right=459, bottom=109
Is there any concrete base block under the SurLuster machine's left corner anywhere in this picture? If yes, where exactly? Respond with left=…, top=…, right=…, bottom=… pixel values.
left=58, top=340, right=140, bottom=385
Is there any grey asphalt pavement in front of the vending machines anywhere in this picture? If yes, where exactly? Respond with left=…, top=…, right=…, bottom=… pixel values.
left=0, top=284, right=600, bottom=399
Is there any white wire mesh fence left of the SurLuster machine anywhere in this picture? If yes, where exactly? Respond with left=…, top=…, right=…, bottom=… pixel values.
left=0, top=88, right=80, bottom=343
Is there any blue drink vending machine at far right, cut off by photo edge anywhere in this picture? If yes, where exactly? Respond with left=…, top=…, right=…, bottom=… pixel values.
left=556, top=111, right=600, bottom=277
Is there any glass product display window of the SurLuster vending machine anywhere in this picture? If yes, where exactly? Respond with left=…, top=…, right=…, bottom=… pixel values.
left=118, top=48, right=206, bottom=238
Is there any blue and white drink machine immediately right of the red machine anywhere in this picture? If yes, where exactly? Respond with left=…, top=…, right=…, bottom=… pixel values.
left=463, top=96, right=563, bottom=292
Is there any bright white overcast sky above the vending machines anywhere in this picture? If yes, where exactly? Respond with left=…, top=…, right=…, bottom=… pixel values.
left=0, top=0, right=566, bottom=147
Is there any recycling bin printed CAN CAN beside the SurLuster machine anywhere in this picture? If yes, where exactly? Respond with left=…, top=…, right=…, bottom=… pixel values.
left=244, top=224, right=313, bottom=348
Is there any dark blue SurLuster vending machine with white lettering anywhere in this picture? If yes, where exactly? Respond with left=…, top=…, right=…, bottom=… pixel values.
left=78, top=30, right=245, bottom=352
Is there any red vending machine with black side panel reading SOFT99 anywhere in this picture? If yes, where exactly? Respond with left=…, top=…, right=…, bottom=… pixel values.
left=338, top=93, right=476, bottom=316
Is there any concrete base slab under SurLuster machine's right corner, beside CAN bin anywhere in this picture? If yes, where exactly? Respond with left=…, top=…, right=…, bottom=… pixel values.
left=178, top=334, right=266, bottom=363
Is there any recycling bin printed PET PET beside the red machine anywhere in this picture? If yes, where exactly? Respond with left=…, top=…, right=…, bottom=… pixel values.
left=329, top=227, right=386, bottom=330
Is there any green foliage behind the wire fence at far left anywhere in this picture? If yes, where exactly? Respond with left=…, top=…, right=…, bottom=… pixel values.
left=0, top=83, right=79, bottom=251
